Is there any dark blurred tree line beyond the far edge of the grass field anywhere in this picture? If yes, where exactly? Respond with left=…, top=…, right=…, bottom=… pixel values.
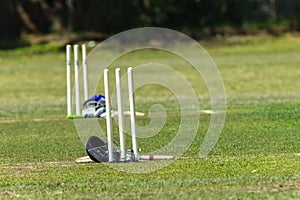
left=0, top=0, right=300, bottom=40
